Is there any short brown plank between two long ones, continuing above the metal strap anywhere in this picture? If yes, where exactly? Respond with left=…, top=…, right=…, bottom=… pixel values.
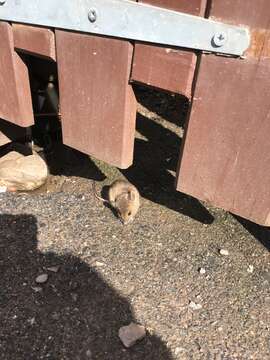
left=131, top=0, right=206, bottom=98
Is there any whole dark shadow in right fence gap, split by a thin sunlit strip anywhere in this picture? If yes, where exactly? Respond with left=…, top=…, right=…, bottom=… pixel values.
left=122, top=86, right=214, bottom=224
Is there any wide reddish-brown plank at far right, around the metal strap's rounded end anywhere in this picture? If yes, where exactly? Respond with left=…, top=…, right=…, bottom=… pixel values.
left=177, top=0, right=270, bottom=226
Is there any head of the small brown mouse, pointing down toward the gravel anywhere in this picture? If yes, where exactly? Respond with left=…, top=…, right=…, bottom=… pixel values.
left=116, top=192, right=139, bottom=225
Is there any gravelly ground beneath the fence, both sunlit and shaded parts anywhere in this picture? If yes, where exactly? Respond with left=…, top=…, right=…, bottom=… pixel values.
left=0, top=87, right=270, bottom=360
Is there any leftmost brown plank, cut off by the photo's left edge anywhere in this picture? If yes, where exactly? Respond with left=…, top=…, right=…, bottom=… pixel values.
left=0, top=22, right=34, bottom=126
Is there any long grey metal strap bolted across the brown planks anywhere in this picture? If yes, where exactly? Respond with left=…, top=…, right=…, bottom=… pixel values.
left=0, top=0, right=250, bottom=56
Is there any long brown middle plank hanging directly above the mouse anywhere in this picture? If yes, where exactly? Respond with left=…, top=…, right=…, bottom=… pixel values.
left=56, top=30, right=136, bottom=168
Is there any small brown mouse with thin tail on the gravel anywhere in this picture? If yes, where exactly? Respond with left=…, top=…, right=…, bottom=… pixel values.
left=93, top=180, right=140, bottom=225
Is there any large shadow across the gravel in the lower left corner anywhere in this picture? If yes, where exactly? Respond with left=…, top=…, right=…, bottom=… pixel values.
left=0, top=215, right=172, bottom=360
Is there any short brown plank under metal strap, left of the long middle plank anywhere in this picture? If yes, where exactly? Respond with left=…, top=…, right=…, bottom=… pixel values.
left=12, top=24, right=56, bottom=61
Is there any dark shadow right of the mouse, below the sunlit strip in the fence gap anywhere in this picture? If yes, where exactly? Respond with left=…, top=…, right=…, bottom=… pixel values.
left=121, top=114, right=214, bottom=224
